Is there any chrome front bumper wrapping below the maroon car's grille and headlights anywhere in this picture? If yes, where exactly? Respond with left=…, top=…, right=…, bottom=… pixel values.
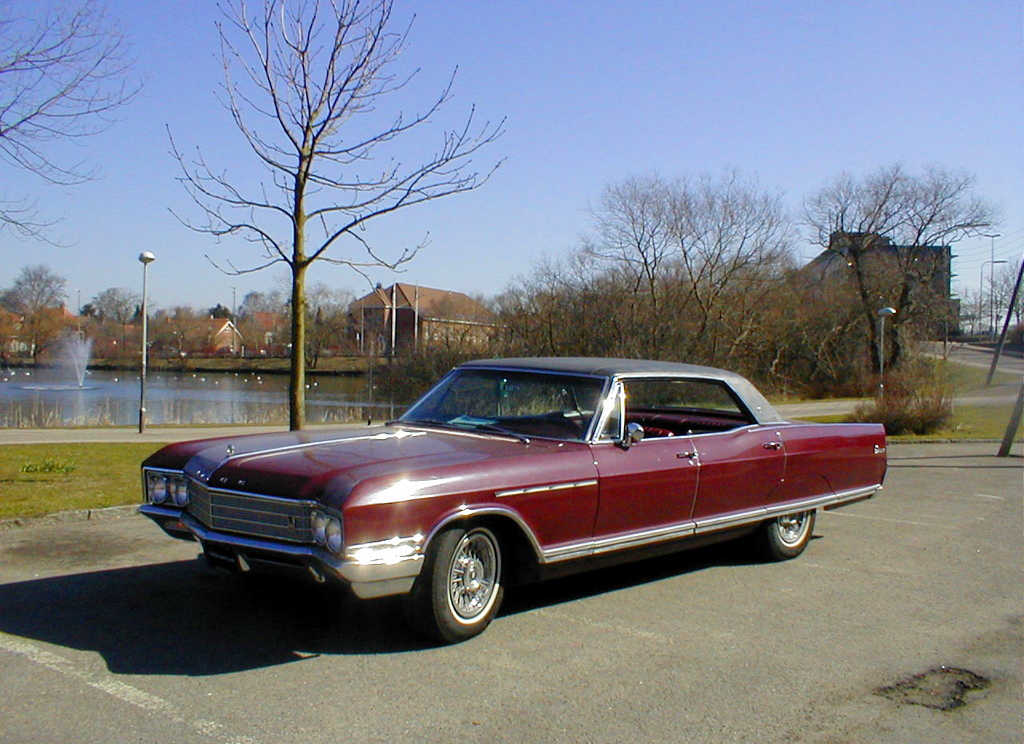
left=138, top=504, right=423, bottom=599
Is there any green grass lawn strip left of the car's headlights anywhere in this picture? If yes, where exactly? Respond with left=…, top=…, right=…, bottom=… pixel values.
left=0, top=442, right=169, bottom=519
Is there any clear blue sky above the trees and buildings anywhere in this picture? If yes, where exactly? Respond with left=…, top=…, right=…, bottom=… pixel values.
left=0, top=0, right=1024, bottom=315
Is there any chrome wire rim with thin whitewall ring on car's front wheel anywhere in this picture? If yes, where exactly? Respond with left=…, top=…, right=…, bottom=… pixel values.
left=447, top=528, right=501, bottom=624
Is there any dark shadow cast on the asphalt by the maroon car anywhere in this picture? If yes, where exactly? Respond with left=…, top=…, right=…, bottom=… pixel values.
left=0, top=543, right=786, bottom=676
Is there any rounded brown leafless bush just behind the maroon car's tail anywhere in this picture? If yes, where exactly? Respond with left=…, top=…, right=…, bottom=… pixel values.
left=850, top=361, right=953, bottom=435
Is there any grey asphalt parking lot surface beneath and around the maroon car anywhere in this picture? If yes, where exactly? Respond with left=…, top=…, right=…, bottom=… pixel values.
left=0, top=443, right=1024, bottom=744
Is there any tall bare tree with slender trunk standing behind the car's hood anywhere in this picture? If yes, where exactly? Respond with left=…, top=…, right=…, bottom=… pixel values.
left=172, top=0, right=502, bottom=429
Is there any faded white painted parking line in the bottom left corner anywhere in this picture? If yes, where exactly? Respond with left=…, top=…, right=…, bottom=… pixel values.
left=0, top=632, right=259, bottom=744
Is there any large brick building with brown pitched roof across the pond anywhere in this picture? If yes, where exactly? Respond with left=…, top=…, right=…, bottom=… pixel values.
left=349, top=282, right=496, bottom=355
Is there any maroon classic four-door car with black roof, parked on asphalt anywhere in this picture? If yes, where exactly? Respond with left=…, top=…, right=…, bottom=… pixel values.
left=141, top=358, right=886, bottom=643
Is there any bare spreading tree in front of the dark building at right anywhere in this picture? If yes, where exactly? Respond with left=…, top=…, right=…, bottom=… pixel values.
left=805, top=165, right=995, bottom=368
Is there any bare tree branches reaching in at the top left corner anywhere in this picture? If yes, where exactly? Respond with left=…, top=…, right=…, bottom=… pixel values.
left=0, top=0, right=138, bottom=236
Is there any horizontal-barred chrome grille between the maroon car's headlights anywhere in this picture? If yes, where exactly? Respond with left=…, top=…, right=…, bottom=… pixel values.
left=186, top=481, right=313, bottom=542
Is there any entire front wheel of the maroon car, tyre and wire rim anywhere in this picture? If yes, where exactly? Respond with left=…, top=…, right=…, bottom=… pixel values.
left=406, top=527, right=505, bottom=644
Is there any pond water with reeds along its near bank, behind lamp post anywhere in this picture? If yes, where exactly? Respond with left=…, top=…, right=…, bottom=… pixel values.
left=0, top=369, right=387, bottom=428
